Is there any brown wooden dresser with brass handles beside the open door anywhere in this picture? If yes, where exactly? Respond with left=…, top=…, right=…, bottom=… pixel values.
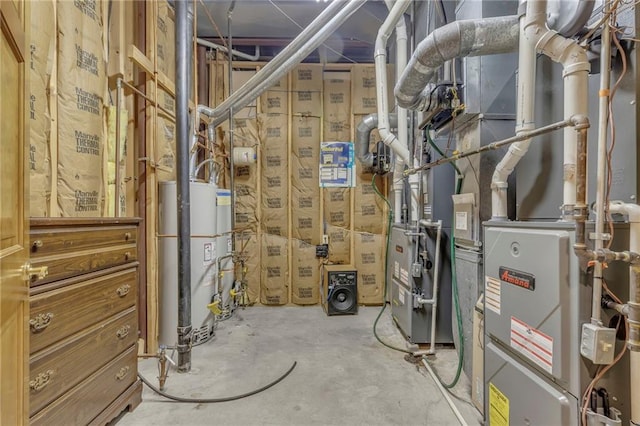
left=29, top=218, right=142, bottom=425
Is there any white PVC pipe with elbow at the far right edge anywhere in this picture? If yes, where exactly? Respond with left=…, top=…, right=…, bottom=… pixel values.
left=609, top=202, right=640, bottom=425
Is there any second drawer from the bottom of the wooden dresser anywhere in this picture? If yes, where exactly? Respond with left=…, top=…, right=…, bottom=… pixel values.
left=29, top=307, right=137, bottom=415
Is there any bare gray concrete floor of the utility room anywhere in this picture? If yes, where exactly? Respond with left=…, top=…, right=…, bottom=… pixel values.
left=118, top=306, right=481, bottom=426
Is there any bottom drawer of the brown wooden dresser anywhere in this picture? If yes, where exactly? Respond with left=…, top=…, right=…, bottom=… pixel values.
left=30, top=345, right=137, bottom=426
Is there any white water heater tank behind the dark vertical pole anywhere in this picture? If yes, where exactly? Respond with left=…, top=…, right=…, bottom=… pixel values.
left=158, top=181, right=217, bottom=346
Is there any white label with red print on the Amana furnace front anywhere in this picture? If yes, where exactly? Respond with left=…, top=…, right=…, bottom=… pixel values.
left=511, top=317, right=553, bottom=373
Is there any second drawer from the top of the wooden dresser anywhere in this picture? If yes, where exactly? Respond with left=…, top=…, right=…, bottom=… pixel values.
left=29, top=263, right=138, bottom=354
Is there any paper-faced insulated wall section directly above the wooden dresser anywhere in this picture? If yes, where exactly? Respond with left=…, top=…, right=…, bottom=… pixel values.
left=29, top=0, right=135, bottom=217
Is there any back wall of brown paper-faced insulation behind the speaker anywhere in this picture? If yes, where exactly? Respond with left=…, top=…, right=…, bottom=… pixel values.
left=209, top=58, right=392, bottom=305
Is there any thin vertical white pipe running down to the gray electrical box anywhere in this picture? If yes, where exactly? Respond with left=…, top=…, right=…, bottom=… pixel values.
left=591, top=1, right=611, bottom=324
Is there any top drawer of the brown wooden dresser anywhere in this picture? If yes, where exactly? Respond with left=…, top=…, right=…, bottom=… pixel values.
left=30, top=225, right=138, bottom=285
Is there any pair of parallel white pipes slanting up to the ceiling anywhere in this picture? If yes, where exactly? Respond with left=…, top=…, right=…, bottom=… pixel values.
left=204, top=0, right=366, bottom=127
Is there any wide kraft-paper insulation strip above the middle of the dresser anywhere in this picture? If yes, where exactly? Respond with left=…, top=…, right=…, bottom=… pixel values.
left=57, top=1, right=107, bottom=217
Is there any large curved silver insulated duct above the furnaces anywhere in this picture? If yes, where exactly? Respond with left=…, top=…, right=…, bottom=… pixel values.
left=395, top=15, right=519, bottom=110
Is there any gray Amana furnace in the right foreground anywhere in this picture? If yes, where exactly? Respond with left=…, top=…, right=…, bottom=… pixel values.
left=484, top=222, right=630, bottom=425
